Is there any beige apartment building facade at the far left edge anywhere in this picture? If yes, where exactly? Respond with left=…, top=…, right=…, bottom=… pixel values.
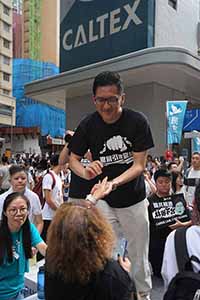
left=0, top=0, right=15, bottom=126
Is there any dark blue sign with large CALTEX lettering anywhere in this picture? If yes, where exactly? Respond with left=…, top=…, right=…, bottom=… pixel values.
left=60, top=0, right=155, bottom=72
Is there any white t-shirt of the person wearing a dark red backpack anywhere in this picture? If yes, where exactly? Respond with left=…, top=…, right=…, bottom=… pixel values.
left=42, top=170, right=63, bottom=220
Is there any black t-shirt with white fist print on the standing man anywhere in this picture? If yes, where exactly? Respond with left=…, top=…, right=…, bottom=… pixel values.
left=69, top=109, right=154, bottom=208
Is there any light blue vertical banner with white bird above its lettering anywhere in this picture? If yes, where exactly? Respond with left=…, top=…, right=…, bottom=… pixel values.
left=166, top=101, right=187, bottom=145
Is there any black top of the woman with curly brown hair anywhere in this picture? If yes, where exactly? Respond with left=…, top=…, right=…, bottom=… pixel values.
left=45, top=261, right=135, bottom=300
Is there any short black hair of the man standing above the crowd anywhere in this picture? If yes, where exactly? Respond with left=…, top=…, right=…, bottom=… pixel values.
left=93, top=71, right=124, bottom=95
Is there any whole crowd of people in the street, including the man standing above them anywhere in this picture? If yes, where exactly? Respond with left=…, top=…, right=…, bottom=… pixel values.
left=0, top=72, right=200, bottom=300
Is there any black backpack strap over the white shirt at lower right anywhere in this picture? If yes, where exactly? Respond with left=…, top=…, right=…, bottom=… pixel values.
left=174, top=227, right=192, bottom=272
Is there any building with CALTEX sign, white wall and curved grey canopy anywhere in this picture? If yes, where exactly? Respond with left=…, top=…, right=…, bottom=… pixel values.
left=25, top=0, right=200, bottom=155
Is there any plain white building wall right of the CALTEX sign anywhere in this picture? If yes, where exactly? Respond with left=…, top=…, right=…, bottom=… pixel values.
left=155, top=0, right=200, bottom=54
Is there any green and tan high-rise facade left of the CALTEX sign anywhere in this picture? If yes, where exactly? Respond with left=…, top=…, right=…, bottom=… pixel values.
left=22, top=0, right=60, bottom=67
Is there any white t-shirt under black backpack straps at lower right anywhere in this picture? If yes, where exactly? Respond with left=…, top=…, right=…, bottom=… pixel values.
left=161, top=225, right=200, bottom=289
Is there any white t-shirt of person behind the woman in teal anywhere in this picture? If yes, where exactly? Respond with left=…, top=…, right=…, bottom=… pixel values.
left=0, top=187, right=42, bottom=224
